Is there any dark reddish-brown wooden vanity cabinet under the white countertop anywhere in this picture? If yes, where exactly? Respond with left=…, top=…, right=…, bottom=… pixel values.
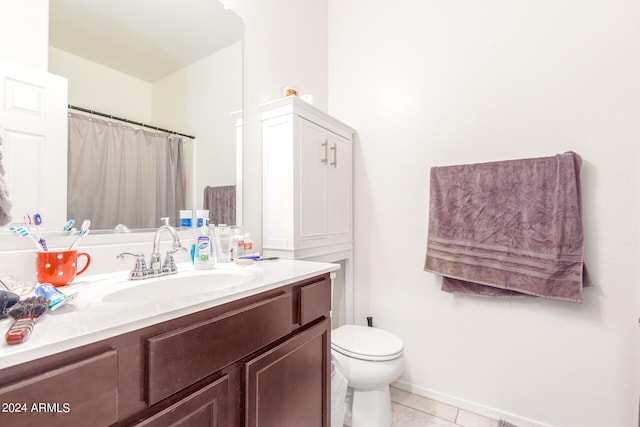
left=0, top=274, right=331, bottom=427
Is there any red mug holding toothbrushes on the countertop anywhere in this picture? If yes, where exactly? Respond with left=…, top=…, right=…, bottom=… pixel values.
left=36, top=250, right=91, bottom=286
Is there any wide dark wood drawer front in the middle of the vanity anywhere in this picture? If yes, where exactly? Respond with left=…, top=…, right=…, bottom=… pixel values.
left=147, top=293, right=292, bottom=405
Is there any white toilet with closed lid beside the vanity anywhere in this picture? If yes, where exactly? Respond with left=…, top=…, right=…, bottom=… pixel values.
left=331, top=325, right=404, bottom=427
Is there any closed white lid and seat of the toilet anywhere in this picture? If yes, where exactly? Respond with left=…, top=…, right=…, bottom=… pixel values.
left=331, top=325, right=404, bottom=361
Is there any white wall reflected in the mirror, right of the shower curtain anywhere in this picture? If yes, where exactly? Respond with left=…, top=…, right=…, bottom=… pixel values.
left=153, top=42, right=242, bottom=209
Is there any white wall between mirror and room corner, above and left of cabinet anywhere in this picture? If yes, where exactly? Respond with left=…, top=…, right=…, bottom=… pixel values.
left=231, top=0, right=328, bottom=247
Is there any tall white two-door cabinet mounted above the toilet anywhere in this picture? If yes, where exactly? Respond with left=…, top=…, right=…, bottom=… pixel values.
left=261, top=96, right=354, bottom=258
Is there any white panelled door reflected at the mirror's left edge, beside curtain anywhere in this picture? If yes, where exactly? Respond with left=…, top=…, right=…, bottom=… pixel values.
left=0, top=61, right=67, bottom=229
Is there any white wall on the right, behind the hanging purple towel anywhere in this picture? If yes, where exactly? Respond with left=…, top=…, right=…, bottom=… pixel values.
left=329, top=0, right=640, bottom=427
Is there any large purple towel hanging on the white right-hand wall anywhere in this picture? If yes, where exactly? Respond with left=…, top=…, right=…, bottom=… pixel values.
left=424, top=152, right=591, bottom=302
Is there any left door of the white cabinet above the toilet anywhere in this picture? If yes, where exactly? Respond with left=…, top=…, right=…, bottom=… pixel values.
left=297, top=118, right=329, bottom=246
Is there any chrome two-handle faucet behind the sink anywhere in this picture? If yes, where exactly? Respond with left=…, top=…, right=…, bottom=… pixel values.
left=118, top=217, right=187, bottom=280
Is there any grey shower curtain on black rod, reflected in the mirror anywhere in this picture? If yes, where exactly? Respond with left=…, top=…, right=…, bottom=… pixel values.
left=67, top=113, right=185, bottom=230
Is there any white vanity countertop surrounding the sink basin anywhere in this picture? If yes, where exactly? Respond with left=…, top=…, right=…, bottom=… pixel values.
left=0, top=259, right=340, bottom=369
